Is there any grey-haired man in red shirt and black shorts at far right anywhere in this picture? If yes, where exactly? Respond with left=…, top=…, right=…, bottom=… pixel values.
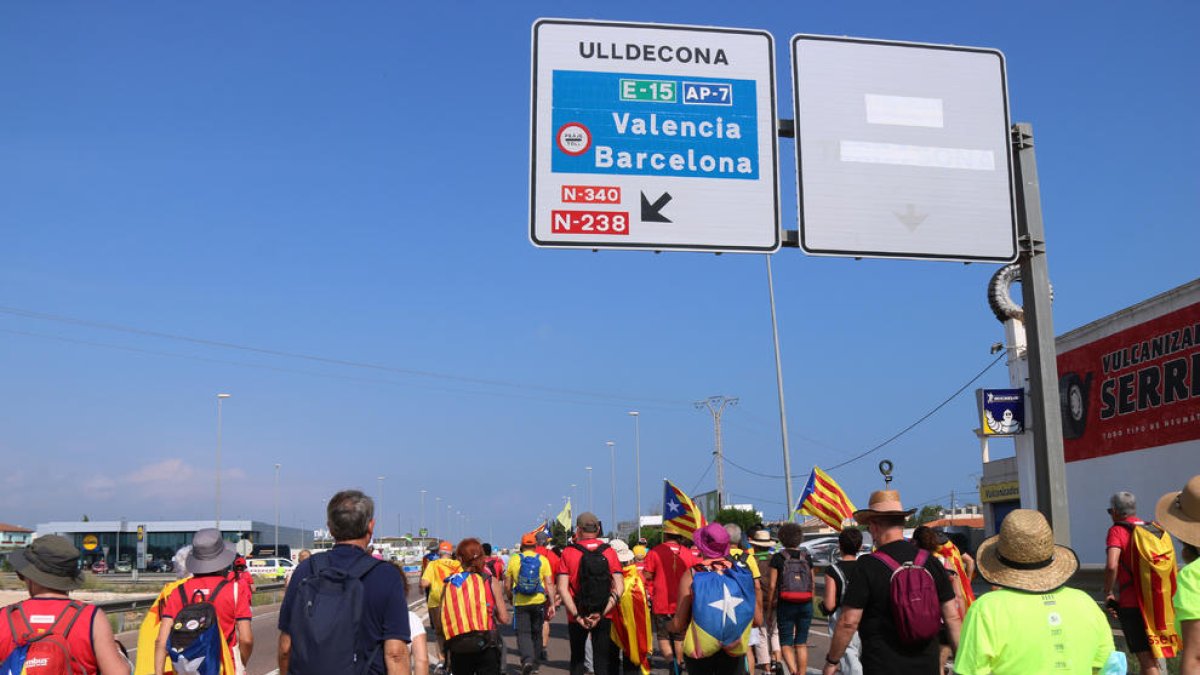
left=1104, top=490, right=1162, bottom=675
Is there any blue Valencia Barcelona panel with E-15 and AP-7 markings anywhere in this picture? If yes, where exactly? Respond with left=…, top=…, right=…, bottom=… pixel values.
left=547, top=71, right=758, bottom=180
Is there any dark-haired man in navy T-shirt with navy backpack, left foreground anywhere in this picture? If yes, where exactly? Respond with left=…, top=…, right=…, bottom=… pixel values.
left=278, top=490, right=410, bottom=675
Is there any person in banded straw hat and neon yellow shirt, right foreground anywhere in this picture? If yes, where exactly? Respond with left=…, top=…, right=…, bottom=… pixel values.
left=954, top=509, right=1124, bottom=675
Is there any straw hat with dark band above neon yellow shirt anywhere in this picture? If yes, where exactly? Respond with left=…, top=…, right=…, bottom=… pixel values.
left=976, top=508, right=1079, bottom=593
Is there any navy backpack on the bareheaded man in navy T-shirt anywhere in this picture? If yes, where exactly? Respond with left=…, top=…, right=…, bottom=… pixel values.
left=280, top=552, right=383, bottom=675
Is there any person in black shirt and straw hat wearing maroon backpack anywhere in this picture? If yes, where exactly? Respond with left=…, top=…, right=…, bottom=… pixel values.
left=823, top=490, right=962, bottom=675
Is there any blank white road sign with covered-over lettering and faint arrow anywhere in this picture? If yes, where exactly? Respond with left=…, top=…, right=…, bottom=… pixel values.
left=792, top=35, right=1016, bottom=262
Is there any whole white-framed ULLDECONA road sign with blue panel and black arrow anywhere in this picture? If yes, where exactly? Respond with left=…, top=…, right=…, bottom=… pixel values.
left=529, top=19, right=780, bottom=251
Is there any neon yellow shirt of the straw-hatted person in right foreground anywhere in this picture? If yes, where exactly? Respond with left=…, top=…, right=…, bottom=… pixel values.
left=954, top=587, right=1115, bottom=675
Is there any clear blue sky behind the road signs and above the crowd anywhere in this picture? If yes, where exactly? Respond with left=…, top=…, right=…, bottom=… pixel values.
left=0, top=2, right=1200, bottom=540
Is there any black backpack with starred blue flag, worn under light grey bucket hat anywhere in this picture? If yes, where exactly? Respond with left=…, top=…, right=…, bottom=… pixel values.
left=167, top=579, right=229, bottom=675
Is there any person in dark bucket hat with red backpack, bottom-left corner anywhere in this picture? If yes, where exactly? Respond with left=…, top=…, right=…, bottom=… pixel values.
left=0, top=534, right=130, bottom=675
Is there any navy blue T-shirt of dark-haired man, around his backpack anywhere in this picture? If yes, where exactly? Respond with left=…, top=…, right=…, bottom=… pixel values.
left=280, top=544, right=412, bottom=673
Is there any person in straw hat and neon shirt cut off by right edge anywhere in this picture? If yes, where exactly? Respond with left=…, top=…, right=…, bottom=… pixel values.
left=1154, top=476, right=1200, bottom=675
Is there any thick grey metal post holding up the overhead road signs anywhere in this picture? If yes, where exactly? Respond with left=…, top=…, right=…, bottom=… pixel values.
left=1012, top=123, right=1070, bottom=546
